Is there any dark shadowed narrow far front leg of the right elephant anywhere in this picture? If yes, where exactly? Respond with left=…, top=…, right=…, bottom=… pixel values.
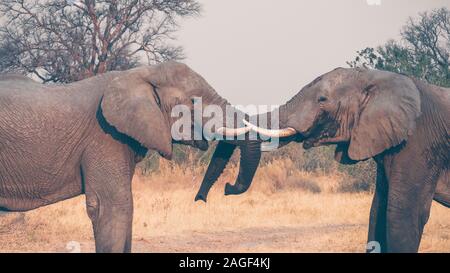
left=366, top=160, right=388, bottom=252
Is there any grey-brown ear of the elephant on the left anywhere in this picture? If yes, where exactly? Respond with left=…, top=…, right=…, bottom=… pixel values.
left=101, top=70, right=172, bottom=159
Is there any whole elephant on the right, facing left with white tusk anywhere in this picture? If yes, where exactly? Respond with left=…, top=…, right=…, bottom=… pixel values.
left=221, top=68, right=450, bottom=252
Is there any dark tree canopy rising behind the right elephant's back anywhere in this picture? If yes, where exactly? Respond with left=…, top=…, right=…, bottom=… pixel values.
left=348, top=8, right=450, bottom=87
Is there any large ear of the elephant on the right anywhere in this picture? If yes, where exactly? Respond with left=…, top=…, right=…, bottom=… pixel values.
left=348, top=75, right=421, bottom=161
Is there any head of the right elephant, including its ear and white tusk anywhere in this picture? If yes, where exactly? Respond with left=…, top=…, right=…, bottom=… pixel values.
left=247, top=68, right=421, bottom=164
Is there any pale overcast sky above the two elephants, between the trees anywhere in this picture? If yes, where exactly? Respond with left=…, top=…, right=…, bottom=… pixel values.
left=178, top=0, right=450, bottom=105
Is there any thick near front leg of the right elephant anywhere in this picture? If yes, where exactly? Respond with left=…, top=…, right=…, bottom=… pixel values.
left=387, top=163, right=437, bottom=253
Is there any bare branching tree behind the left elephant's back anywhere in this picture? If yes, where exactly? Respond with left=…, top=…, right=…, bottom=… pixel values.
left=0, top=0, right=200, bottom=83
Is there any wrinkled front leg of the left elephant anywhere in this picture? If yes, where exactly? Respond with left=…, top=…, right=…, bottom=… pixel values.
left=82, top=142, right=134, bottom=252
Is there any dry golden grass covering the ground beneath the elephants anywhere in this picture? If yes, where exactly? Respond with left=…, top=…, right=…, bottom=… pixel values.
left=0, top=160, right=450, bottom=252
